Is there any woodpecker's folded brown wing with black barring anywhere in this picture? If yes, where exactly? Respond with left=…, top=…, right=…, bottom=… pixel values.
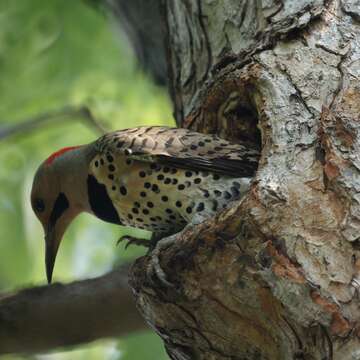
left=95, top=126, right=259, bottom=177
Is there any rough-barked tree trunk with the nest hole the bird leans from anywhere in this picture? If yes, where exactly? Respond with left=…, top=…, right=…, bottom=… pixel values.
left=131, top=0, right=360, bottom=360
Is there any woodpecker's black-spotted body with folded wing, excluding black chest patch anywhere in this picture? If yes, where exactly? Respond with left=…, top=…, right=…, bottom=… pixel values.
left=90, top=127, right=258, bottom=234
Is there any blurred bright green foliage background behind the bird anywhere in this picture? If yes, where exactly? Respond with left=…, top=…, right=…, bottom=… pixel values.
left=0, top=0, right=173, bottom=360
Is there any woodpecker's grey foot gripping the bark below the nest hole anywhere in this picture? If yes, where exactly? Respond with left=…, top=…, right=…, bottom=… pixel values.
left=147, top=234, right=177, bottom=288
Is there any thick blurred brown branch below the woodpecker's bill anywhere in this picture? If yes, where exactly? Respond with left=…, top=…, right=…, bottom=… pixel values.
left=0, top=266, right=146, bottom=355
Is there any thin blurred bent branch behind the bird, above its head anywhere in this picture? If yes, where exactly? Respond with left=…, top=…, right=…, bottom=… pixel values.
left=0, top=106, right=106, bottom=140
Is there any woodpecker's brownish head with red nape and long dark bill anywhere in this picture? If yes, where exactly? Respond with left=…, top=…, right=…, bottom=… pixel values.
left=31, top=147, right=89, bottom=283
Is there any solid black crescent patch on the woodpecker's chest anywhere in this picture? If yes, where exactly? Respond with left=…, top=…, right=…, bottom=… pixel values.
left=87, top=175, right=121, bottom=224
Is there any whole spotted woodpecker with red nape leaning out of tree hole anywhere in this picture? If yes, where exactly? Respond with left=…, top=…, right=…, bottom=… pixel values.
left=31, top=126, right=260, bottom=283
